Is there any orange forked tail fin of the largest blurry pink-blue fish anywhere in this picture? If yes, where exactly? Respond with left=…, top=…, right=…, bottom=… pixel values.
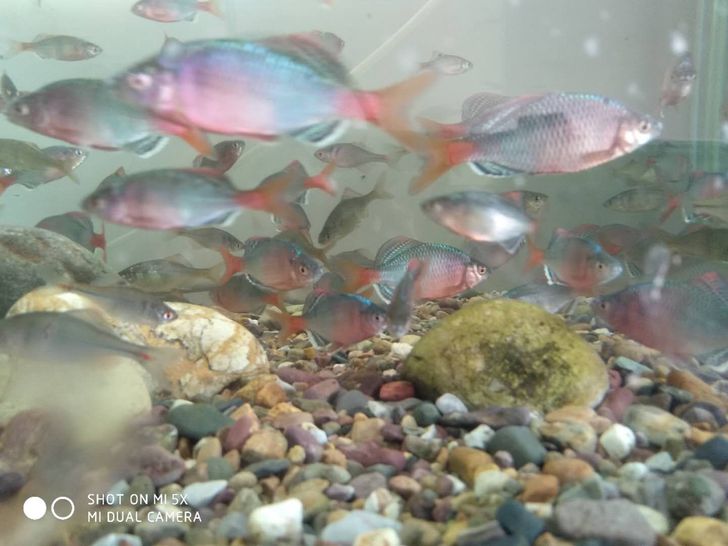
left=370, top=70, right=437, bottom=151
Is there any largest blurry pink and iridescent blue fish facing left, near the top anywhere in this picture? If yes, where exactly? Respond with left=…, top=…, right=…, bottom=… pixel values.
left=113, top=34, right=436, bottom=154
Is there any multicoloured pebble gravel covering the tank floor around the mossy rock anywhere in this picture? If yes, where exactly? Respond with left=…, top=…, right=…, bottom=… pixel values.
left=25, top=299, right=728, bottom=546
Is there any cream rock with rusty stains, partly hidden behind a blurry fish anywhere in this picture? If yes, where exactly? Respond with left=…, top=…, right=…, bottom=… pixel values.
left=8, top=286, right=269, bottom=400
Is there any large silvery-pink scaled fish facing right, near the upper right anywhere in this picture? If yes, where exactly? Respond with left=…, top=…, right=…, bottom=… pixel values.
left=411, top=93, right=662, bottom=193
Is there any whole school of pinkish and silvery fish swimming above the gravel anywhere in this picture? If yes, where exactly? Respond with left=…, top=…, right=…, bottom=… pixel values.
left=0, top=0, right=728, bottom=362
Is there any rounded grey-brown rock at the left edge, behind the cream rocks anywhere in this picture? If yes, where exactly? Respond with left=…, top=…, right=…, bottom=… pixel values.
left=0, top=226, right=111, bottom=316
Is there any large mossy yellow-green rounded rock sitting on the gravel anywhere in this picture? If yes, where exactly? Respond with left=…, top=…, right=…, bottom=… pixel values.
left=404, top=300, right=608, bottom=411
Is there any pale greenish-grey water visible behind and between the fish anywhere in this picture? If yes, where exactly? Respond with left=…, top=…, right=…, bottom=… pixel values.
left=3, top=0, right=725, bottom=280
